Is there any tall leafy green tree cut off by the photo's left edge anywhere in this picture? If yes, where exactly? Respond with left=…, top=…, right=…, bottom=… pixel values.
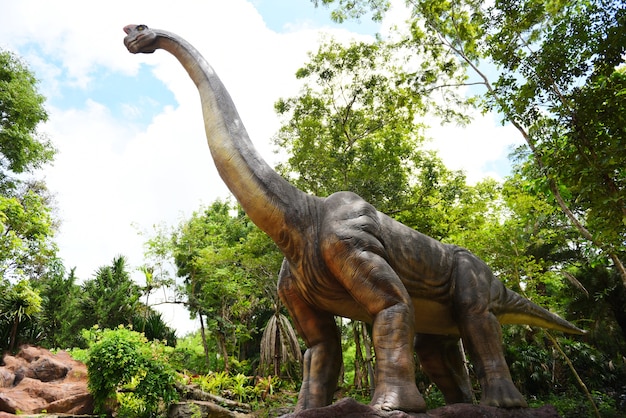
left=0, top=51, right=56, bottom=280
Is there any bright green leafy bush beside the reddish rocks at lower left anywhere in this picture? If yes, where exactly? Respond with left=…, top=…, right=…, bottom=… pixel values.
left=87, top=326, right=178, bottom=417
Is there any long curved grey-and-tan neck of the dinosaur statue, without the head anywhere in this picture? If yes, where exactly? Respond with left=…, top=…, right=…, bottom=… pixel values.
left=156, top=30, right=305, bottom=241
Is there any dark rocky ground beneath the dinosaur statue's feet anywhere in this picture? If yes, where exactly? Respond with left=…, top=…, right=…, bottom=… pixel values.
left=282, top=398, right=560, bottom=418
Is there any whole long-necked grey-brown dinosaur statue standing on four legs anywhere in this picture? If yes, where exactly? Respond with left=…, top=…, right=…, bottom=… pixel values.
left=124, top=25, right=584, bottom=411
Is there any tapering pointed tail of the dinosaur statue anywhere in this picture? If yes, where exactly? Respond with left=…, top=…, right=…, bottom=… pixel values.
left=493, top=286, right=587, bottom=335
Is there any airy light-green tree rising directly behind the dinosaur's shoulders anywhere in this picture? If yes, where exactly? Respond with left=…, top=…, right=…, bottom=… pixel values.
left=275, top=41, right=423, bottom=213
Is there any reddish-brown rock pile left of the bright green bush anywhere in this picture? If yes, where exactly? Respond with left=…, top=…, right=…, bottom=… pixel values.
left=0, top=346, right=93, bottom=418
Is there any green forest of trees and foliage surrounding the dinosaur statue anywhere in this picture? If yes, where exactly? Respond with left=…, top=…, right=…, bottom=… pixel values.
left=0, top=0, right=626, bottom=416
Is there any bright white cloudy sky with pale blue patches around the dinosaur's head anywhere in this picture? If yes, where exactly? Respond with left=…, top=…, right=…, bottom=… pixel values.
left=0, top=0, right=520, bottom=336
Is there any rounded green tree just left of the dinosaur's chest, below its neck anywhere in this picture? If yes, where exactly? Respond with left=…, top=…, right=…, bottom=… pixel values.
left=172, top=200, right=281, bottom=370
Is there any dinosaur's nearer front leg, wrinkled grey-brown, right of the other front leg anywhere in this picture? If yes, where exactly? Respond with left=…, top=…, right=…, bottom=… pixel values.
left=325, top=245, right=426, bottom=412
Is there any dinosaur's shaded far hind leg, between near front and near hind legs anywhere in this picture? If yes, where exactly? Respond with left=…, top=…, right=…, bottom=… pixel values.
left=415, top=334, right=473, bottom=404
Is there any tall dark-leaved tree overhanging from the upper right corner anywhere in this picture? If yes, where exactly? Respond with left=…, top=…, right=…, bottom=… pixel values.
left=313, top=0, right=626, bottom=286
